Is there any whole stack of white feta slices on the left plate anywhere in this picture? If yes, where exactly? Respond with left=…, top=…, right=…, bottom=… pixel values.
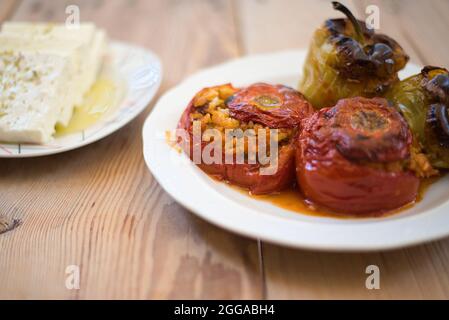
left=0, top=23, right=106, bottom=143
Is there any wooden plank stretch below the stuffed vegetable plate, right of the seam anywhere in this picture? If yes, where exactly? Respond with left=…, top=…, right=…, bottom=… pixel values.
left=263, top=240, right=449, bottom=299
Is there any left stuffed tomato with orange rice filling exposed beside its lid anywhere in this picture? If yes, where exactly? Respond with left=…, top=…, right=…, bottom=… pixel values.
left=178, top=83, right=313, bottom=194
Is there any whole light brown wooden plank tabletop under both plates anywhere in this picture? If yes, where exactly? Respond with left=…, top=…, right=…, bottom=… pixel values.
left=0, top=0, right=449, bottom=299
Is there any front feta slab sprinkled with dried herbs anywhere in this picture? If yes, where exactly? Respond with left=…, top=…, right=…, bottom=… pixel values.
left=0, top=49, right=74, bottom=144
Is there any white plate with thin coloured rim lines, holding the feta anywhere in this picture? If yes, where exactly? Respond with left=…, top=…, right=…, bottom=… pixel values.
left=0, top=42, right=162, bottom=158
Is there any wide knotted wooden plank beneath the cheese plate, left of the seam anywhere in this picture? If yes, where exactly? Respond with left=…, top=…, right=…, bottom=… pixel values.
left=0, top=0, right=262, bottom=299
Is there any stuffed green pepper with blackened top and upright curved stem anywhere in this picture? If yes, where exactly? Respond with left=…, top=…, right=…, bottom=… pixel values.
left=299, top=1, right=409, bottom=109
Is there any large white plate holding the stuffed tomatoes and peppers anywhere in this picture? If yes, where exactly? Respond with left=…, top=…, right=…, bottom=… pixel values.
left=143, top=51, right=449, bottom=251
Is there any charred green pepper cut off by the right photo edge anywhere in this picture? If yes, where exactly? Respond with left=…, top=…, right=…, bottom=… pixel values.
left=386, top=66, right=449, bottom=169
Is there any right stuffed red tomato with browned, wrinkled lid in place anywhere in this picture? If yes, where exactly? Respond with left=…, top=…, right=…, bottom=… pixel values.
left=296, top=97, right=422, bottom=214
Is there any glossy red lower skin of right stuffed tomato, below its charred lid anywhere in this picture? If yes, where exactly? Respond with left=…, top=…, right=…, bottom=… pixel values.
left=296, top=108, right=420, bottom=214
